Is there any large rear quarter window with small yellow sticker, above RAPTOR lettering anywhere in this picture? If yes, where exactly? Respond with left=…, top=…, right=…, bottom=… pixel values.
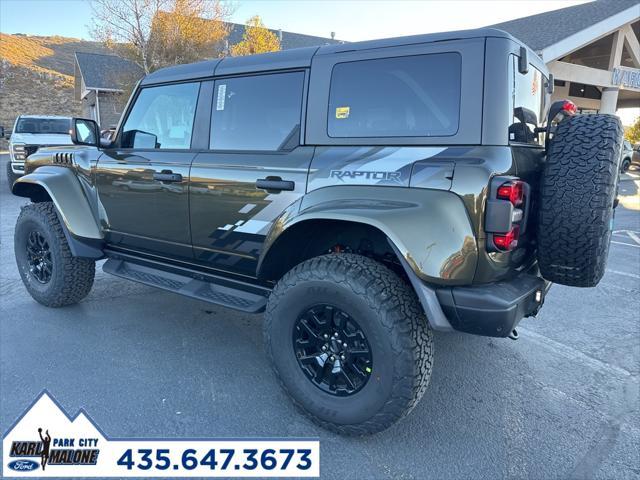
left=328, top=53, right=462, bottom=138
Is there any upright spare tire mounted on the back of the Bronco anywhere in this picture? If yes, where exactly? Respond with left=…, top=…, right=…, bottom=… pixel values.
left=538, top=115, right=622, bottom=287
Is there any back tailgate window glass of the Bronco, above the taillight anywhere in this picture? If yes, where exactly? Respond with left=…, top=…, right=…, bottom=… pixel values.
left=509, top=55, right=545, bottom=144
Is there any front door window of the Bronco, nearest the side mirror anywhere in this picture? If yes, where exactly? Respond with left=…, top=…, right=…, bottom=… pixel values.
left=121, top=83, right=200, bottom=149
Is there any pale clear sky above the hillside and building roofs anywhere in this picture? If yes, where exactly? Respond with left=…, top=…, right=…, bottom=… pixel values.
left=0, top=0, right=585, bottom=41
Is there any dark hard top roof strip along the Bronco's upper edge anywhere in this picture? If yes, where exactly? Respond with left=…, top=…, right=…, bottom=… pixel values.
left=141, top=28, right=520, bottom=85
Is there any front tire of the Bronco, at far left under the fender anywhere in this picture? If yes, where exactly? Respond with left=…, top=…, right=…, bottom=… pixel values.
left=14, top=202, right=95, bottom=307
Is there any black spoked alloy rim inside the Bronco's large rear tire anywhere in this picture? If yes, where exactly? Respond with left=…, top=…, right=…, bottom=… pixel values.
left=293, top=304, right=373, bottom=397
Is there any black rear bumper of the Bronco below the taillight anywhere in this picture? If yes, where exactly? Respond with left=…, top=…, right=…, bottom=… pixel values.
left=436, top=273, right=551, bottom=337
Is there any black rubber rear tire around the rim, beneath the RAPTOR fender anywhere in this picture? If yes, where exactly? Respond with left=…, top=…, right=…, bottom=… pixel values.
left=264, top=254, right=433, bottom=435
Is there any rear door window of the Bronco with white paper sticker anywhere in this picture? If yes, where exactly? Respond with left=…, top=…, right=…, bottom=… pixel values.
left=210, top=72, right=304, bottom=151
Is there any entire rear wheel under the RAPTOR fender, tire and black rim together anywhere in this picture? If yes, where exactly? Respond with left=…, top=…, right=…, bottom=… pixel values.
left=264, top=253, right=433, bottom=435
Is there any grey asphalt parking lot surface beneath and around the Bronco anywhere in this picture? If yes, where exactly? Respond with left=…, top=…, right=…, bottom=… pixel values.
left=0, top=155, right=640, bottom=479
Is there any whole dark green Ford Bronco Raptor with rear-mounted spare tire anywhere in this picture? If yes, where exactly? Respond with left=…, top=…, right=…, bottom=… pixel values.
left=12, top=29, right=622, bottom=435
